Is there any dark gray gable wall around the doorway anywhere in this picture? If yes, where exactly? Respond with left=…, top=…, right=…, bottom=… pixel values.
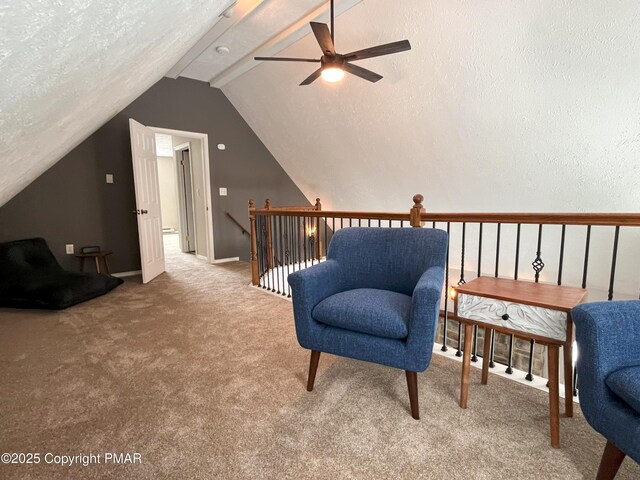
left=0, top=78, right=308, bottom=272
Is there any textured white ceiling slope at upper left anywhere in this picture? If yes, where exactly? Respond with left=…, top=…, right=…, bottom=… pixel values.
left=0, top=0, right=230, bottom=206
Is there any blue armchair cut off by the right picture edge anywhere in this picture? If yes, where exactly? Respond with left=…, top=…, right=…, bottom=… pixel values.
left=572, top=300, right=640, bottom=479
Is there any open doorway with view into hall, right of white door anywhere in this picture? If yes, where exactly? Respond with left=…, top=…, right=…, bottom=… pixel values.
left=152, top=128, right=214, bottom=262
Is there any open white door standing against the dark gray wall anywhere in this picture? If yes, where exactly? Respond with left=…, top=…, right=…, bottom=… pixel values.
left=129, top=118, right=164, bottom=283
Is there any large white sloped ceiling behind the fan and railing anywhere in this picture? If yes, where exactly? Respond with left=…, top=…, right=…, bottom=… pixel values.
left=222, top=0, right=640, bottom=212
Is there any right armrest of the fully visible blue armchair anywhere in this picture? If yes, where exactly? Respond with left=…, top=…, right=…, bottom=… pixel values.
left=407, top=266, right=444, bottom=368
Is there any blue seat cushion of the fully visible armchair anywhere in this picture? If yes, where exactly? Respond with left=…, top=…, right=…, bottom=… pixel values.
left=311, top=288, right=411, bottom=339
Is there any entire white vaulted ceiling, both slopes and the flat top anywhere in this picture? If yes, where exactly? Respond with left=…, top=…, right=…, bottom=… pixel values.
left=0, top=0, right=640, bottom=218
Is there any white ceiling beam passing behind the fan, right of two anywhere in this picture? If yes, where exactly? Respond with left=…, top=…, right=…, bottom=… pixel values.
left=209, top=0, right=362, bottom=88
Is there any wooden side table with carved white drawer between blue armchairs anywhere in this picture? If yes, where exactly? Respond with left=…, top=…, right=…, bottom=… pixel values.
left=454, top=277, right=587, bottom=448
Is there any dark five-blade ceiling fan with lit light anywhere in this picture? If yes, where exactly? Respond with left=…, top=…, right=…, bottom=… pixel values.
left=254, top=0, right=411, bottom=86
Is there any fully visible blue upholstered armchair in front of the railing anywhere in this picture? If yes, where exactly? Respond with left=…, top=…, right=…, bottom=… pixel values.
left=289, top=228, right=447, bottom=419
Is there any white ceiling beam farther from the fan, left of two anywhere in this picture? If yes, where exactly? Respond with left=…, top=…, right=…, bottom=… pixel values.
left=165, top=0, right=263, bottom=78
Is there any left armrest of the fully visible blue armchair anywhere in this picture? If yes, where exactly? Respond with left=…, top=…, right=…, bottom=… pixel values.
left=287, top=260, right=344, bottom=348
